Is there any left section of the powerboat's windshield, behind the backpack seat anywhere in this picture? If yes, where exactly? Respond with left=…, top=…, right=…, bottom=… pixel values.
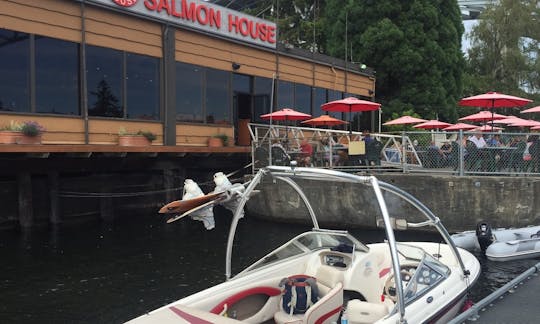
left=238, top=230, right=369, bottom=276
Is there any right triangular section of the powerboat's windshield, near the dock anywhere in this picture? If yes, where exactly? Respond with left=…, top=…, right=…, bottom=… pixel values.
left=397, top=243, right=450, bottom=304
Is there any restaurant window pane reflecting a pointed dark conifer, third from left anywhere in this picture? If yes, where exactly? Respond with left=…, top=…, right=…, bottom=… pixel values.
left=86, top=46, right=124, bottom=118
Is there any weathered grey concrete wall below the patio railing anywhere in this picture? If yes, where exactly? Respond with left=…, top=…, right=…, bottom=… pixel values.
left=247, top=173, right=540, bottom=232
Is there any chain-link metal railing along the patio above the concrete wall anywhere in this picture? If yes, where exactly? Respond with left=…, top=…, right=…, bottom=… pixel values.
left=249, top=124, right=540, bottom=176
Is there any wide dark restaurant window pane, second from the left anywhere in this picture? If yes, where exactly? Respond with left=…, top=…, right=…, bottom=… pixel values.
left=35, top=36, right=80, bottom=115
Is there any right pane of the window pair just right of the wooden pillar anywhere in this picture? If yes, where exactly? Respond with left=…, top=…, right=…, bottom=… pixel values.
left=206, top=69, right=231, bottom=124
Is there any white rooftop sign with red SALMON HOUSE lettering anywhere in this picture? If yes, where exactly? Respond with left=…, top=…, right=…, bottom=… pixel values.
left=83, top=0, right=277, bottom=48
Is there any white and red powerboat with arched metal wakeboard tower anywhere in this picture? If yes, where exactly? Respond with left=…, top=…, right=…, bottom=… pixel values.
left=128, top=166, right=480, bottom=324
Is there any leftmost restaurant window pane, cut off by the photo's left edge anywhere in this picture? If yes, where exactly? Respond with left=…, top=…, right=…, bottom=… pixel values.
left=0, top=28, right=30, bottom=112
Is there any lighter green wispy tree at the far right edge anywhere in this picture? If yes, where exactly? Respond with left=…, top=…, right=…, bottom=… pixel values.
left=465, top=0, right=540, bottom=99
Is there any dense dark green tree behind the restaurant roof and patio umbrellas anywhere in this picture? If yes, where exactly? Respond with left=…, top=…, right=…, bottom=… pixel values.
left=325, top=0, right=464, bottom=121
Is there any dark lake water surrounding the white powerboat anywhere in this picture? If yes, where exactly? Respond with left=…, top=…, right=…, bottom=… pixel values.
left=0, top=207, right=538, bottom=323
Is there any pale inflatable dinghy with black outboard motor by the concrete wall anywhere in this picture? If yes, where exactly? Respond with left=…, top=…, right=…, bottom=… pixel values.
left=451, top=222, right=540, bottom=261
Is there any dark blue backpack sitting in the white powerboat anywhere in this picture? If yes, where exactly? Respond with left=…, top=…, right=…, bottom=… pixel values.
left=279, top=275, right=318, bottom=315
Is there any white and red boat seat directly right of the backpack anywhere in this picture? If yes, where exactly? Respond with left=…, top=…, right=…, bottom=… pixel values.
left=274, top=265, right=343, bottom=324
